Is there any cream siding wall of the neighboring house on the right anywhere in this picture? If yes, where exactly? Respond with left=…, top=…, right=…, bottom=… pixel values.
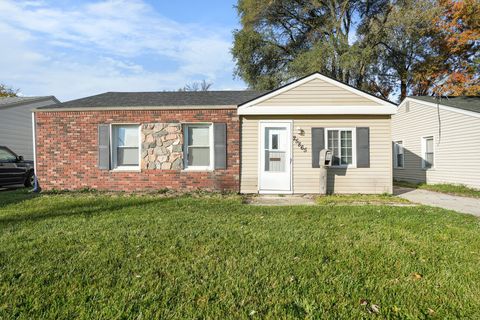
left=392, top=101, right=480, bottom=188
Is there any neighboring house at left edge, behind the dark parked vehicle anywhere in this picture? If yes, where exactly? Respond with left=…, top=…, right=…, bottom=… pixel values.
left=0, top=96, right=60, bottom=160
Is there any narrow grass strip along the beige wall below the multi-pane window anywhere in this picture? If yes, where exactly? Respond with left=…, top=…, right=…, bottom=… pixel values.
left=316, top=194, right=410, bottom=205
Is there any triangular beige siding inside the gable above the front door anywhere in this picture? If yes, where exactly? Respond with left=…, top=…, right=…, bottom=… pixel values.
left=257, top=79, right=380, bottom=106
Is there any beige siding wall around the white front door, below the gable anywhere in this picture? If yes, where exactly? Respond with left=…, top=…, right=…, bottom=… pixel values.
left=240, top=116, right=392, bottom=193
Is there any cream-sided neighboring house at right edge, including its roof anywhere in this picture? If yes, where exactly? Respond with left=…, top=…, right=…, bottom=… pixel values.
left=392, top=96, right=480, bottom=188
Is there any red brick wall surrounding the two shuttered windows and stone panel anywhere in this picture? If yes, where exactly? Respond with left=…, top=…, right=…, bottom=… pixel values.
left=36, top=109, right=240, bottom=191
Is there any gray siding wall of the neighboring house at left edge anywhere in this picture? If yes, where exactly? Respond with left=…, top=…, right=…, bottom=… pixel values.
left=0, top=100, right=55, bottom=160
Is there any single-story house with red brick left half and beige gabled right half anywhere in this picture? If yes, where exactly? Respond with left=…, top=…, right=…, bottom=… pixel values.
left=35, top=73, right=396, bottom=193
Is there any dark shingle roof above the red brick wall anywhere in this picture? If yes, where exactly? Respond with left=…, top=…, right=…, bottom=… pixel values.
left=38, top=90, right=264, bottom=109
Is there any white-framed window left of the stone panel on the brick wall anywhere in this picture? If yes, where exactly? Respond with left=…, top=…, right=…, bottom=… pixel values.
left=112, top=124, right=140, bottom=170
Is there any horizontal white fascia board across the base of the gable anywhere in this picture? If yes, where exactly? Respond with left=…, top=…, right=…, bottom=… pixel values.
left=238, top=105, right=397, bottom=115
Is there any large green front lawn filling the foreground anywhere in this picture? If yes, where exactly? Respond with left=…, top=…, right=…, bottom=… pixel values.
left=0, top=191, right=480, bottom=319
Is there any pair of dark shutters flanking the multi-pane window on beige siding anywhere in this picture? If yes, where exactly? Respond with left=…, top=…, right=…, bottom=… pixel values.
left=312, top=127, right=370, bottom=168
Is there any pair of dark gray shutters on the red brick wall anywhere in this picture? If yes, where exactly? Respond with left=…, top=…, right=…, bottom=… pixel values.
left=98, top=123, right=227, bottom=170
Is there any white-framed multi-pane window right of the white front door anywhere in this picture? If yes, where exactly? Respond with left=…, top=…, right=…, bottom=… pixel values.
left=326, top=129, right=355, bottom=166
